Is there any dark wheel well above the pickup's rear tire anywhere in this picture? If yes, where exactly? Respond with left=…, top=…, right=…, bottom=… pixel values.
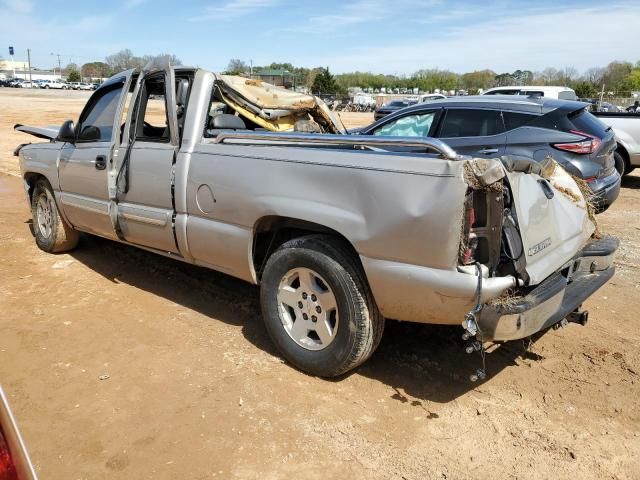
left=252, top=216, right=360, bottom=281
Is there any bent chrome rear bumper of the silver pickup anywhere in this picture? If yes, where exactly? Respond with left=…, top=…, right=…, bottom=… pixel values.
left=478, top=237, right=619, bottom=341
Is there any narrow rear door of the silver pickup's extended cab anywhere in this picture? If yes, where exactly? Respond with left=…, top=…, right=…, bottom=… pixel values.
left=115, top=67, right=185, bottom=253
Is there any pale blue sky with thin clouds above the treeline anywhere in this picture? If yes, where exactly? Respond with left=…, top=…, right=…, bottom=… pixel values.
left=0, top=0, right=640, bottom=74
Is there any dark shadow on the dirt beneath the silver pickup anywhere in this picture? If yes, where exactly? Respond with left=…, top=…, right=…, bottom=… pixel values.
left=71, top=236, right=535, bottom=403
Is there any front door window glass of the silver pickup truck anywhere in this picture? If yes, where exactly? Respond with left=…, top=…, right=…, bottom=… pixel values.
left=77, top=83, right=122, bottom=142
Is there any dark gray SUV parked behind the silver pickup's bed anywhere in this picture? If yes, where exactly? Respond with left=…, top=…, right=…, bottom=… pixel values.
left=353, top=95, right=620, bottom=209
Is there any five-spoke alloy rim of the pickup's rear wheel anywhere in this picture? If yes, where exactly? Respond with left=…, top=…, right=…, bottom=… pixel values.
left=277, top=267, right=338, bottom=350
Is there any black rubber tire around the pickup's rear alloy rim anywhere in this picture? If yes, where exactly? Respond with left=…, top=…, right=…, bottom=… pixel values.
left=260, top=235, right=384, bottom=377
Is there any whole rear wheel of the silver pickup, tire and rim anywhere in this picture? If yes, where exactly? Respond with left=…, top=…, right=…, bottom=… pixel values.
left=260, top=235, right=384, bottom=377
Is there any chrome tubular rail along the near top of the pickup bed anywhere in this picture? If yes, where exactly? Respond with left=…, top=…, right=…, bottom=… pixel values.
left=213, top=131, right=466, bottom=160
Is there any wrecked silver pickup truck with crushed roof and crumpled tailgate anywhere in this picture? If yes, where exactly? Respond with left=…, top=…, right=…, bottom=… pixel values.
left=16, top=65, right=618, bottom=376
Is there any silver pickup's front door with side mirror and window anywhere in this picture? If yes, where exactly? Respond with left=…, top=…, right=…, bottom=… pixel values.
left=58, top=70, right=134, bottom=237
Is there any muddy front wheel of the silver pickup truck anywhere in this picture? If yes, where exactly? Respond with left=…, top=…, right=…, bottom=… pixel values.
left=31, top=180, right=79, bottom=253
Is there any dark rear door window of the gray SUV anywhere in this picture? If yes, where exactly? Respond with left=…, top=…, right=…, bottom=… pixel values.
left=439, top=108, right=503, bottom=138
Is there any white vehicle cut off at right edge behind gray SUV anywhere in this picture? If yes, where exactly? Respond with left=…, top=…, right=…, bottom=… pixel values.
left=594, top=112, right=640, bottom=175
